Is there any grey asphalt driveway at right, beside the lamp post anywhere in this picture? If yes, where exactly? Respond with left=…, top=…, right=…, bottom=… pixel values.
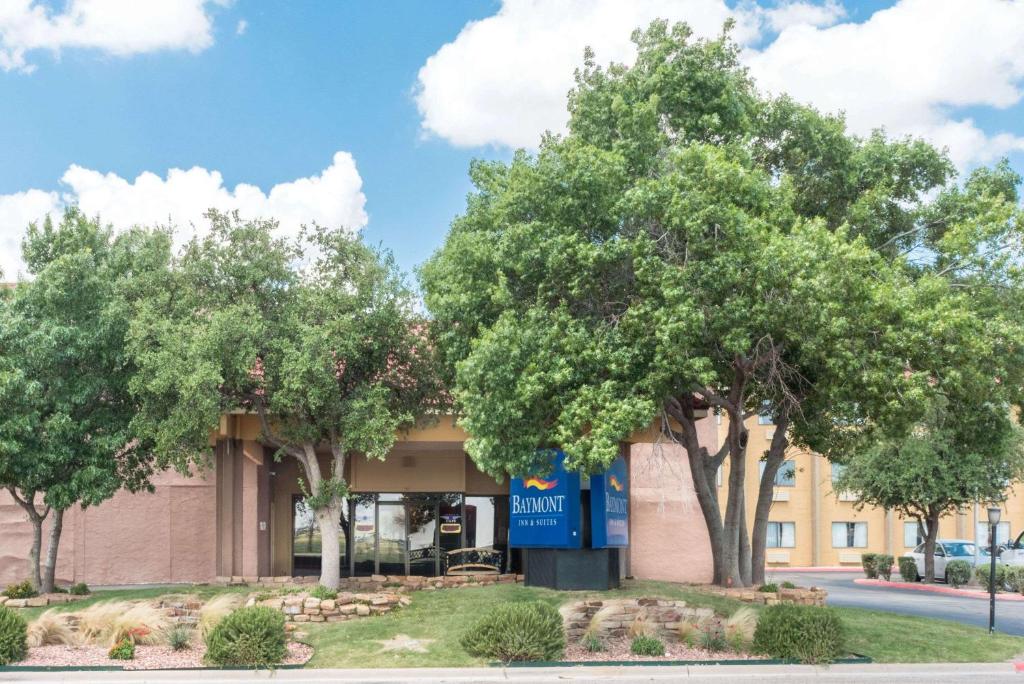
left=768, top=572, right=1024, bottom=634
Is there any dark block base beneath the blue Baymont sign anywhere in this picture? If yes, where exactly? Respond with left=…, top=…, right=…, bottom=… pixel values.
left=523, top=549, right=620, bottom=591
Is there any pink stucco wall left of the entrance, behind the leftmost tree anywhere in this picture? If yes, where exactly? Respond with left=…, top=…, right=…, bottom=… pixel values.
left=0, top=472, right=217, bottom=586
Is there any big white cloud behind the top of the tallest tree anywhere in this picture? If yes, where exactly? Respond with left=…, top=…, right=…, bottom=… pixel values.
left=416, top=0, right=1024, bottom=167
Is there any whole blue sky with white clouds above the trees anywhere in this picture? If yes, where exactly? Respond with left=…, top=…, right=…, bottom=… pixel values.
left=0, top=0, right=1024, bottom=281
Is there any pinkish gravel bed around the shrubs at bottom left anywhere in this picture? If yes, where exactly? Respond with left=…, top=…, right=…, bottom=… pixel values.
left=13, top=641, right=313, bottom=670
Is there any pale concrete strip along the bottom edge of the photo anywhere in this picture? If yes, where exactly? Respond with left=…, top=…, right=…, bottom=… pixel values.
left=0, top=662, right=1024, bottom=684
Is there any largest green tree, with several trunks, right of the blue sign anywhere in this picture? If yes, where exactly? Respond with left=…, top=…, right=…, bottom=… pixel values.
left=421, top=23, right=1019, bottom=585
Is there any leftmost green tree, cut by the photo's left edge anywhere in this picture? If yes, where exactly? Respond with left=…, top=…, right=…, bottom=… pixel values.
left=0, top=209, right=167, bottom=592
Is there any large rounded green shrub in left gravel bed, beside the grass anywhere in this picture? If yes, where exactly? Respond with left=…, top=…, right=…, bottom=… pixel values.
left=206, top=605, right=288, bottom=667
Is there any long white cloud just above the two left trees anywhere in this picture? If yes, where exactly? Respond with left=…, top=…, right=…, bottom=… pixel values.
left=0, top=152, right=369, bottom=280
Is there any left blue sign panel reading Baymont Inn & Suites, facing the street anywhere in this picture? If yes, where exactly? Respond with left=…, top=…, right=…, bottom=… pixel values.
left=509, top=452, right=583, bottom=549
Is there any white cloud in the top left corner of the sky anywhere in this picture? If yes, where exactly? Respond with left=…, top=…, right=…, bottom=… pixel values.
left=0, top=0, right=230, bottom=72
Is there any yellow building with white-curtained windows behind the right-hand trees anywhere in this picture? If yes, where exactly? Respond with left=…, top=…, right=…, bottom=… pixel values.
left=711, top=416, right=1024, bottom=568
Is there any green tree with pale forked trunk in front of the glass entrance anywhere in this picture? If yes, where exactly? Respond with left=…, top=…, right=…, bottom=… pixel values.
left=130, top=212, right=443, bottom=588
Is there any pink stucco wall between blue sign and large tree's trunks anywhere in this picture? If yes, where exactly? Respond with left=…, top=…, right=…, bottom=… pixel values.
left=630, top=418, right=717, bottom=583
